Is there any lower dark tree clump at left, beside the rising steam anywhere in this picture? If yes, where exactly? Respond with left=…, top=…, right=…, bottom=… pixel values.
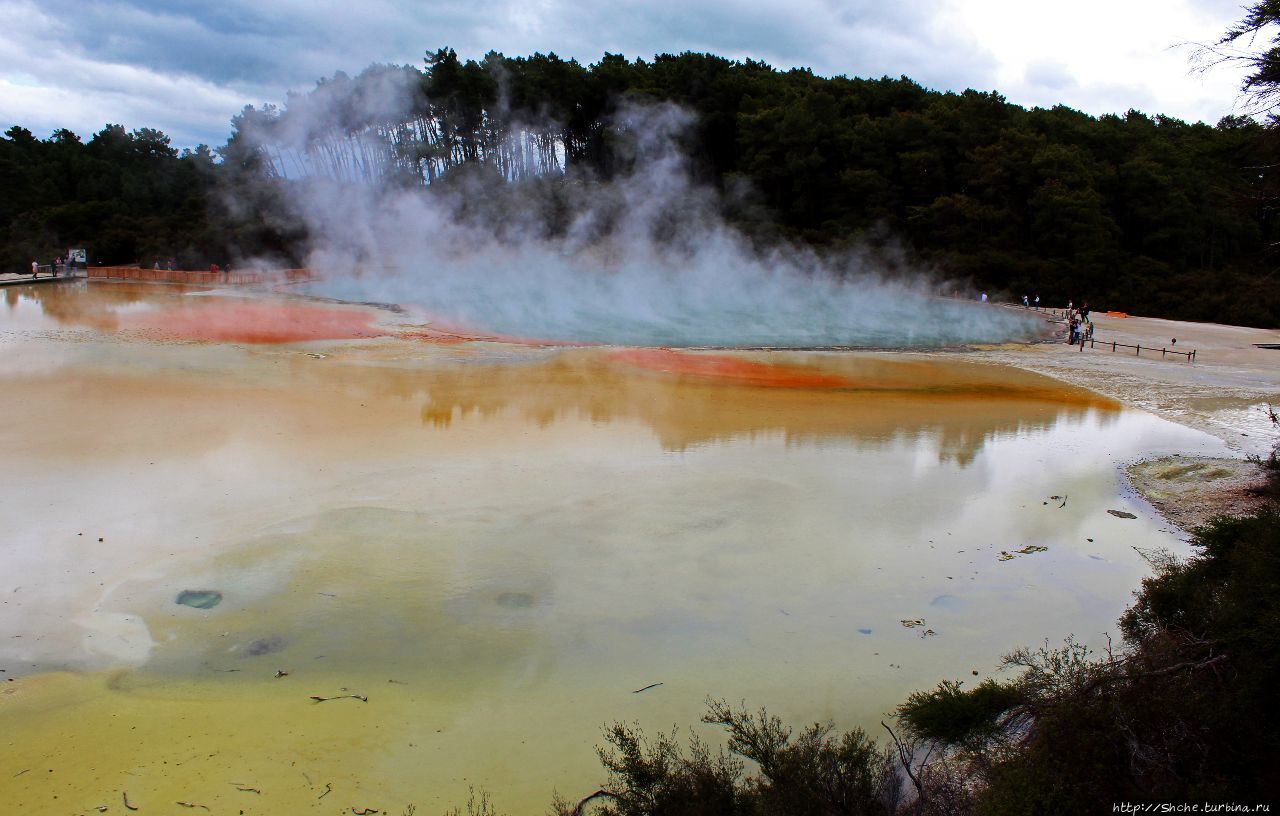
left=0, top=124, right=306, bottom=272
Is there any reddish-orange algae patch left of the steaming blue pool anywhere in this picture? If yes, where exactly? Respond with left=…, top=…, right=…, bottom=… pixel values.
left=122, top=303, right=387, bottom=343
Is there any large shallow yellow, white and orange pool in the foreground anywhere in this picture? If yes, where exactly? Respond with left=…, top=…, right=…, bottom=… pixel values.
left=0, top=283, right=1222, bottom=815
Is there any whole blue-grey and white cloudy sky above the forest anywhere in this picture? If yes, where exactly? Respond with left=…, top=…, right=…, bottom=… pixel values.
left=0, top=0, right=1259, bottom=146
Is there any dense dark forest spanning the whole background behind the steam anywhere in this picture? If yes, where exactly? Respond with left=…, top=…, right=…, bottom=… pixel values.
left=0, top=49, right=1280, bottom=326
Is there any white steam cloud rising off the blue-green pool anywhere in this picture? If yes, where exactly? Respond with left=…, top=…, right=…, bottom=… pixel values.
left=238, top=79, right=1043, bottom=348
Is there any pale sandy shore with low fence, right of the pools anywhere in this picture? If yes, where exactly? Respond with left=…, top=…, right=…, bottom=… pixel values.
left=973, top=313, right=1280, bottom=531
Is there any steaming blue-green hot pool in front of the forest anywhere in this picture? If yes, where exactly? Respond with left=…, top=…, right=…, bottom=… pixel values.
left=297, top=267, right=1044, bottom=349
